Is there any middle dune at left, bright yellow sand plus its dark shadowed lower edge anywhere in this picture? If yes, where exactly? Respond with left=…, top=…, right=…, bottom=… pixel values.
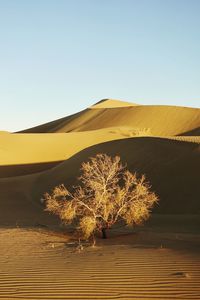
left=0, top=127, right=142, bottom=177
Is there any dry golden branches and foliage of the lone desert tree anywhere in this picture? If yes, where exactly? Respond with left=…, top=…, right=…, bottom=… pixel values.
left=44, top=154, right=158, bottom=239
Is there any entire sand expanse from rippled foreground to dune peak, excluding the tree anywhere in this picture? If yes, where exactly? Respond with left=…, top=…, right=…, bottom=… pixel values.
left=0, top=99, right=200, bottom=300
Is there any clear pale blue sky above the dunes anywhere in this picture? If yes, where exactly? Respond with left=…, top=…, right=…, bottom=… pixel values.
left=0, top=0, right=200, bottom=131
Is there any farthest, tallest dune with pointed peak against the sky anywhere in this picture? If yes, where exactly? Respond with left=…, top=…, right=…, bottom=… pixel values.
left=18, top=100, right=200, bottom=136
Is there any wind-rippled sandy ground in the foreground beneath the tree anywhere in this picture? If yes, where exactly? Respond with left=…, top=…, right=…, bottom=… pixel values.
left=0, top=216, right=200, bottom=300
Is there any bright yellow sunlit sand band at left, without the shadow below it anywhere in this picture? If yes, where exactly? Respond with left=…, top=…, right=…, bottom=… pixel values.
left=0, top=129, right=127, bottom=165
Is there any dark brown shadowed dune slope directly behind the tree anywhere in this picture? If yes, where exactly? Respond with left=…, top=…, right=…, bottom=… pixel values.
left=0, top=137, right=200, bottom=224
